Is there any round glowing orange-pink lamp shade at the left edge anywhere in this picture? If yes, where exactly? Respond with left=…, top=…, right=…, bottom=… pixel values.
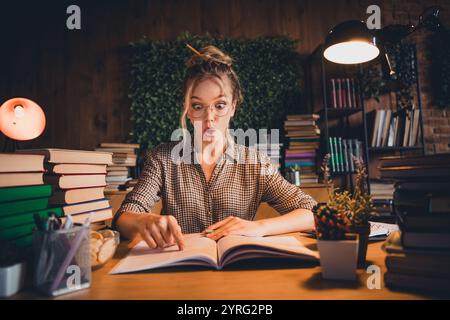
left=0, top=98, right=45, bottom=141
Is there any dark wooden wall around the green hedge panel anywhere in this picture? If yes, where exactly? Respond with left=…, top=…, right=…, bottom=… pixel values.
left=0, top=0, right=450, bottom=153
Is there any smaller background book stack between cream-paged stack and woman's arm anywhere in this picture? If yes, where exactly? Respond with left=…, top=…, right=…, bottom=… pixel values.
left=95, top=142, right=139, bottom=191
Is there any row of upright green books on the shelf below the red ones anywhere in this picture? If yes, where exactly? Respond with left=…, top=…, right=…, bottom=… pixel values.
left=328, top=137, right=363, bottom=173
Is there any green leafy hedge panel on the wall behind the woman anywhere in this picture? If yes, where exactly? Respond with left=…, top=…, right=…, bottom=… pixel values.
left=129, top=34, right=302, bottom=149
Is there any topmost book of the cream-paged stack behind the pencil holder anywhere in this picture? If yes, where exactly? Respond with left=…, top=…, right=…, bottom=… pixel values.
left=17, top=149, right=112, bottom=164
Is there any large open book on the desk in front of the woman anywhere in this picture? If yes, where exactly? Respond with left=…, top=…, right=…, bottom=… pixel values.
left=110, top=233, right=319, bottom=274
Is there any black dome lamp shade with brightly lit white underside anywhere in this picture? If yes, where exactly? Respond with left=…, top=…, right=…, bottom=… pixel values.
left=323, top=20, right=380, bottom=64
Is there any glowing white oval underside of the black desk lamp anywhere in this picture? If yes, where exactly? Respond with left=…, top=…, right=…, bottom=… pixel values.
left=323, top=41, right=380, bottom=64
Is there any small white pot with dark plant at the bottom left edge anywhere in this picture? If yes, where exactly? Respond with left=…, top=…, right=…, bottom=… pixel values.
left=0, top=241, right=26, bottom=298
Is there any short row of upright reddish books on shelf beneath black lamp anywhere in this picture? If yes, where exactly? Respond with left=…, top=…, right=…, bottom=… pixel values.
left=330, top=78, right=361, bottom=109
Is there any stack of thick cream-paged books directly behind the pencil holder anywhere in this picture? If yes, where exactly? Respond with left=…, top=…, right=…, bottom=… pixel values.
left=17, top=149, right=112, bottom=225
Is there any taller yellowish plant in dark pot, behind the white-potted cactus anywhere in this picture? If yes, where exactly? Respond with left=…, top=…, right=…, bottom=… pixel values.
left=316, top=154, right=374, bottom=268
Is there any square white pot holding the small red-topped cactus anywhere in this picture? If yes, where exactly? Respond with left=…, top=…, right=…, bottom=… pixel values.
left=317, top=234, right=358, bottom=280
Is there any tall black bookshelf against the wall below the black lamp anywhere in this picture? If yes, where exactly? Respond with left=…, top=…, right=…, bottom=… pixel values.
left=305, top=44, right=425, bottom=218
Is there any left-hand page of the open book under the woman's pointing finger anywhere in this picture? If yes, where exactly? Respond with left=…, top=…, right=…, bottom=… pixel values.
left=110, top=233, right=217, bottom=274
